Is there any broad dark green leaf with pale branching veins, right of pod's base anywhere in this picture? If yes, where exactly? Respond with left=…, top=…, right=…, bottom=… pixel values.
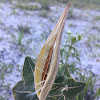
left=47, top=76, right=86, bottom=100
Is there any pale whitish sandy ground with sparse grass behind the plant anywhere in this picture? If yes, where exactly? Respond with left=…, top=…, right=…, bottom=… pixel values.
left=0, top=2, right=100, bottom=100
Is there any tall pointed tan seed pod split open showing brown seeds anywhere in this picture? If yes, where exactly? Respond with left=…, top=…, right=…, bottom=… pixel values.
left=34, top=3, right=70, bottom=100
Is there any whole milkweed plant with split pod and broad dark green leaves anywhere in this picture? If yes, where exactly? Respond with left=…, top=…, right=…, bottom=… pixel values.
left=12, top=3, right=86, bottom=100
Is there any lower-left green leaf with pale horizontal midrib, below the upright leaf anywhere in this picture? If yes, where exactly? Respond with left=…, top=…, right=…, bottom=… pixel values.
left=12, top=81, right=38, bottom=100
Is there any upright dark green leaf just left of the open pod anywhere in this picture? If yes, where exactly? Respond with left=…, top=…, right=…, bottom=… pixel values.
left=23, top=57, right=35, bottom=86
